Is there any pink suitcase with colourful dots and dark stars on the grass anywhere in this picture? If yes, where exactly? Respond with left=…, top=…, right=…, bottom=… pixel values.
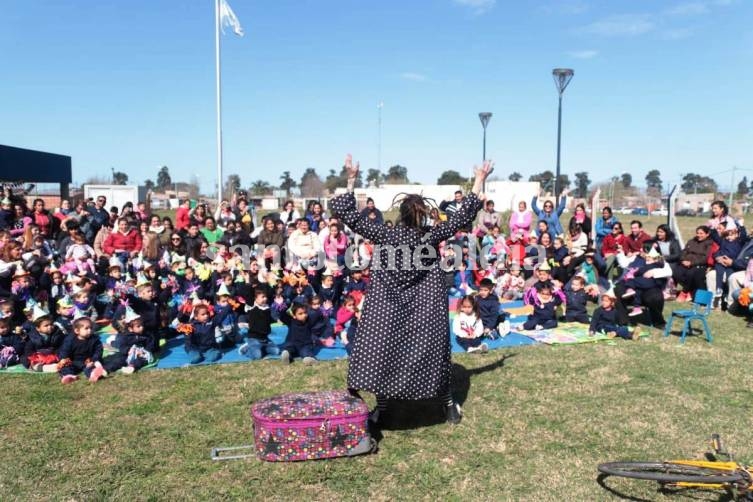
left=251, top=391, right=376, bottom=462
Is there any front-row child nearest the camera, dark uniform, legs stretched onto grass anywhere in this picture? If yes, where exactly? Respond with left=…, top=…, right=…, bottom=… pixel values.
left=57, top=317, right=107, bottom=384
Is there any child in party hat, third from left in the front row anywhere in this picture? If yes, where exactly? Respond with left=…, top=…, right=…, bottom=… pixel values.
left=103, top=307, right=155, bottom=375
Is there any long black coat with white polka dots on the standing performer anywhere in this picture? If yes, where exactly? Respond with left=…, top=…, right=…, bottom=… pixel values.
left=330, top=194, right=481, bottom=399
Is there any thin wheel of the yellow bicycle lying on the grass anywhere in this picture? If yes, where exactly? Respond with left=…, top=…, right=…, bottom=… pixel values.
left=598, top=462, right=743, bottom=483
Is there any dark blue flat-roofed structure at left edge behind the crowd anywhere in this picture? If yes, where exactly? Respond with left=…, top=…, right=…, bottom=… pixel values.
left=0, top=145, right=73, bottom=199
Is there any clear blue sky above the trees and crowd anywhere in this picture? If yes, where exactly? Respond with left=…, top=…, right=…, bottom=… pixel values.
left=0, top=0, right=753, bottom=191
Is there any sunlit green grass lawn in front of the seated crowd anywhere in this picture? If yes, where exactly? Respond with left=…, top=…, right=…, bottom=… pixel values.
left=0, top=304, right=753, bottom=500
